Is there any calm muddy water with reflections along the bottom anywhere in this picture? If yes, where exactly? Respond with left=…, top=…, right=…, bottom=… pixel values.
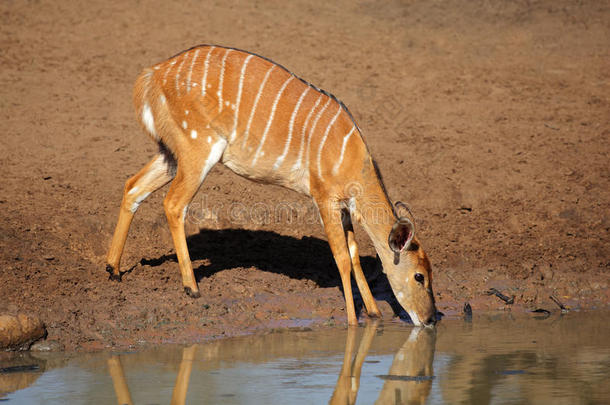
left=0, top=311, right=610, bottom=404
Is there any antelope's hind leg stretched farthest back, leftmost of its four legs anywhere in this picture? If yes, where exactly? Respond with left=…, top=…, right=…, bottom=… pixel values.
left=106, top=153, right=175, bottom=281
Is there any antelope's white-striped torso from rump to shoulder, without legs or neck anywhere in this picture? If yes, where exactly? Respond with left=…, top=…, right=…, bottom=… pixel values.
left=134, top=45, right=368, bottom=194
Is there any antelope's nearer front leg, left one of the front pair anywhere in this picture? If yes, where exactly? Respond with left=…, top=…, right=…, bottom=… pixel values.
left=318, top=202, right=358, bottom=325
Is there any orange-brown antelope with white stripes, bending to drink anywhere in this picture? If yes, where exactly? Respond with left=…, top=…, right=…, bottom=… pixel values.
left=106, top=45, right=436, bottom=325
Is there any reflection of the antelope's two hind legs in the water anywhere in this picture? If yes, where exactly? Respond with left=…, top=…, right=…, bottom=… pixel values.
left=108, top=345, right=197, bottom=405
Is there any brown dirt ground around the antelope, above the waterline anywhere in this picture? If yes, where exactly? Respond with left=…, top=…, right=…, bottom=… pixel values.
left=0, top=0, right=610, bottom=350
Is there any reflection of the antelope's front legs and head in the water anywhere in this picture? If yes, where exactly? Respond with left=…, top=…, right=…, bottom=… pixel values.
left=329, top=322, right=436, bottom=405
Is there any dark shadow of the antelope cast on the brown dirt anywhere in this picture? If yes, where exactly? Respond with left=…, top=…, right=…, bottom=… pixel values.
left=140, top=229, right=409, bottom=320
